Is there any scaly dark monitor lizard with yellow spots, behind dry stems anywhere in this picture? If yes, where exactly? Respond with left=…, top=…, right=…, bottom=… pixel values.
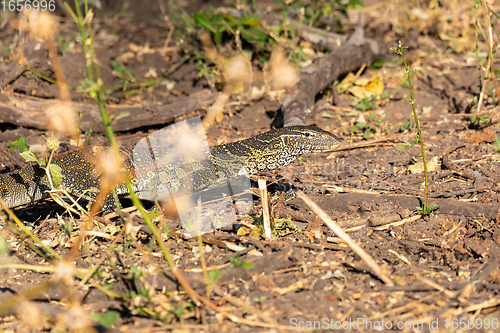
left=0, top=126, right=340, bottom=208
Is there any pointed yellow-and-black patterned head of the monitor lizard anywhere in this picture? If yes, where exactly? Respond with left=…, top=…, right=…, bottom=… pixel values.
left=279, top=126, right=340, bottom=154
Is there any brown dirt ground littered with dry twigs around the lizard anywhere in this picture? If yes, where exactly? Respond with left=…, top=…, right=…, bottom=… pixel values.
left=0, top=0, right=500, bottom=332
